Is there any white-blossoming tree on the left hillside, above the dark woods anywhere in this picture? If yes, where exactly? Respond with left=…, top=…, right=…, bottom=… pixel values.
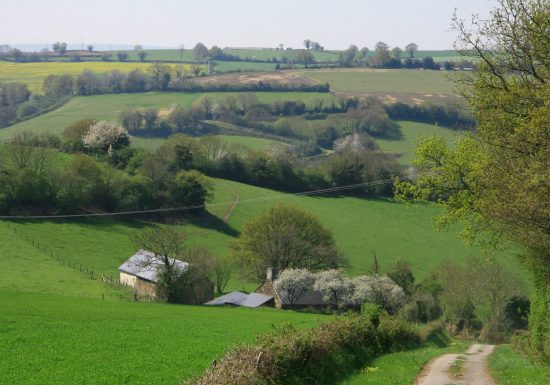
left=82, top=120, right=130, bottom=152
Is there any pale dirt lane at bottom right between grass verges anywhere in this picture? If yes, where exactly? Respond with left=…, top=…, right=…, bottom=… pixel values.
left=415, top=344, right=495, bottom=385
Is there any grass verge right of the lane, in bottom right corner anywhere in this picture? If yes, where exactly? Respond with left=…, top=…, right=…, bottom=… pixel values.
left=489, top=345, right=550, bottom=385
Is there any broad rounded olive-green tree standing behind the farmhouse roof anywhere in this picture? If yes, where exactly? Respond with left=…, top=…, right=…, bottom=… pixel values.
left=233, top=204, right=343, bottom=279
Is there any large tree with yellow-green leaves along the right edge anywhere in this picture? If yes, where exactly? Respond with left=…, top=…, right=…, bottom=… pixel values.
left=398, top=0, right=550, bottom=361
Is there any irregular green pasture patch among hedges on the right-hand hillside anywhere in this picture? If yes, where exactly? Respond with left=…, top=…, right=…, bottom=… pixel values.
left=376, top=121, right=460, bottom=165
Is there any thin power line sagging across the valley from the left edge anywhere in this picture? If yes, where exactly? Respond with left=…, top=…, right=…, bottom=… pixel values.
left=0, top=176, right=414, bottom=219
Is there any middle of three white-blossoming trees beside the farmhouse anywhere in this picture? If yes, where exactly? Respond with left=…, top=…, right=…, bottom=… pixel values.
left=313, top=269, right=353, bottom=308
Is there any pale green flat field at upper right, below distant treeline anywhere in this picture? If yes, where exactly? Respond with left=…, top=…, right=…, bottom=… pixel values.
left=301, top=69, right=453, bottom=94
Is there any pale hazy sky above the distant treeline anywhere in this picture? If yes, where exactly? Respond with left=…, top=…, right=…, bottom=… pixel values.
left=0, top=0, right=493, bottom=49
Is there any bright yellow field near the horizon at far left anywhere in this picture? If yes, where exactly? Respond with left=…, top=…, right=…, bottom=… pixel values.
left=0, top=61, right=196, bottom=92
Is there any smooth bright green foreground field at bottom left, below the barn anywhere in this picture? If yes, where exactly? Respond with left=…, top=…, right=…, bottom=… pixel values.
left=0, top=290, right=326, bottom=385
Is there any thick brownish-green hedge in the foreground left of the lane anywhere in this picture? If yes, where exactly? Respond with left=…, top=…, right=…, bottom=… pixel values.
left=191, top=315, right=420, bottom=385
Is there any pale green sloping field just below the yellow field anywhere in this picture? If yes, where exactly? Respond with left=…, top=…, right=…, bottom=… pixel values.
left=0, top=92, right=334, bottom=141
